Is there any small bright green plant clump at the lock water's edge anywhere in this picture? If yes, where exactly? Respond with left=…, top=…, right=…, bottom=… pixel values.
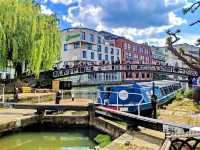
left=94, top=134, right=111, bottom=148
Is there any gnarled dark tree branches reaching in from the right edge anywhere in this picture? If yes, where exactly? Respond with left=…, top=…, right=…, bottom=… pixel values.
left=167, top=1, right=200, bottom=75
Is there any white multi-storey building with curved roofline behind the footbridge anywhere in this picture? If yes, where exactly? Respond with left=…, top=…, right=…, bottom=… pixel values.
left=61, top=28, right=121, bottom=84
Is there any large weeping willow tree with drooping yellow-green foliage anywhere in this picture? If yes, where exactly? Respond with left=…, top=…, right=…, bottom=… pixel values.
left=0, top=0, right=61, bottom=76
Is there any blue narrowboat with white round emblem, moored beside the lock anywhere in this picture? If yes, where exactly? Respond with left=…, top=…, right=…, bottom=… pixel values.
left=98, top=80, right=182, bottom=113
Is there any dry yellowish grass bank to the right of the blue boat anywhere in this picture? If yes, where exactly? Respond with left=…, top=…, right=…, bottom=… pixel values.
left=158, top=89, right=200, bottom=126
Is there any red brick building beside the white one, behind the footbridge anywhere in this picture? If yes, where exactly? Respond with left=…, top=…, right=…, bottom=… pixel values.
left=115, top=37, right=152, bottom=81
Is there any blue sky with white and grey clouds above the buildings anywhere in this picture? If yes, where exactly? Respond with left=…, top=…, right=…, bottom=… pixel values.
left=36, top=0, right=200, bottom=46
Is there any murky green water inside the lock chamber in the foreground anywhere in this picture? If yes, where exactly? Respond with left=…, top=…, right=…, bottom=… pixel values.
left=0, top=128, right=96, bottom=150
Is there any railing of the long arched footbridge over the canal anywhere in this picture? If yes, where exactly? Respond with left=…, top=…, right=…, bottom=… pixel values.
left=53, top=64, right=197, bottom=78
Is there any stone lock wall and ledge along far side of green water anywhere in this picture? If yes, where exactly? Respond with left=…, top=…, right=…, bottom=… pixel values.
left=0, top=109, right=126, bottom=139
